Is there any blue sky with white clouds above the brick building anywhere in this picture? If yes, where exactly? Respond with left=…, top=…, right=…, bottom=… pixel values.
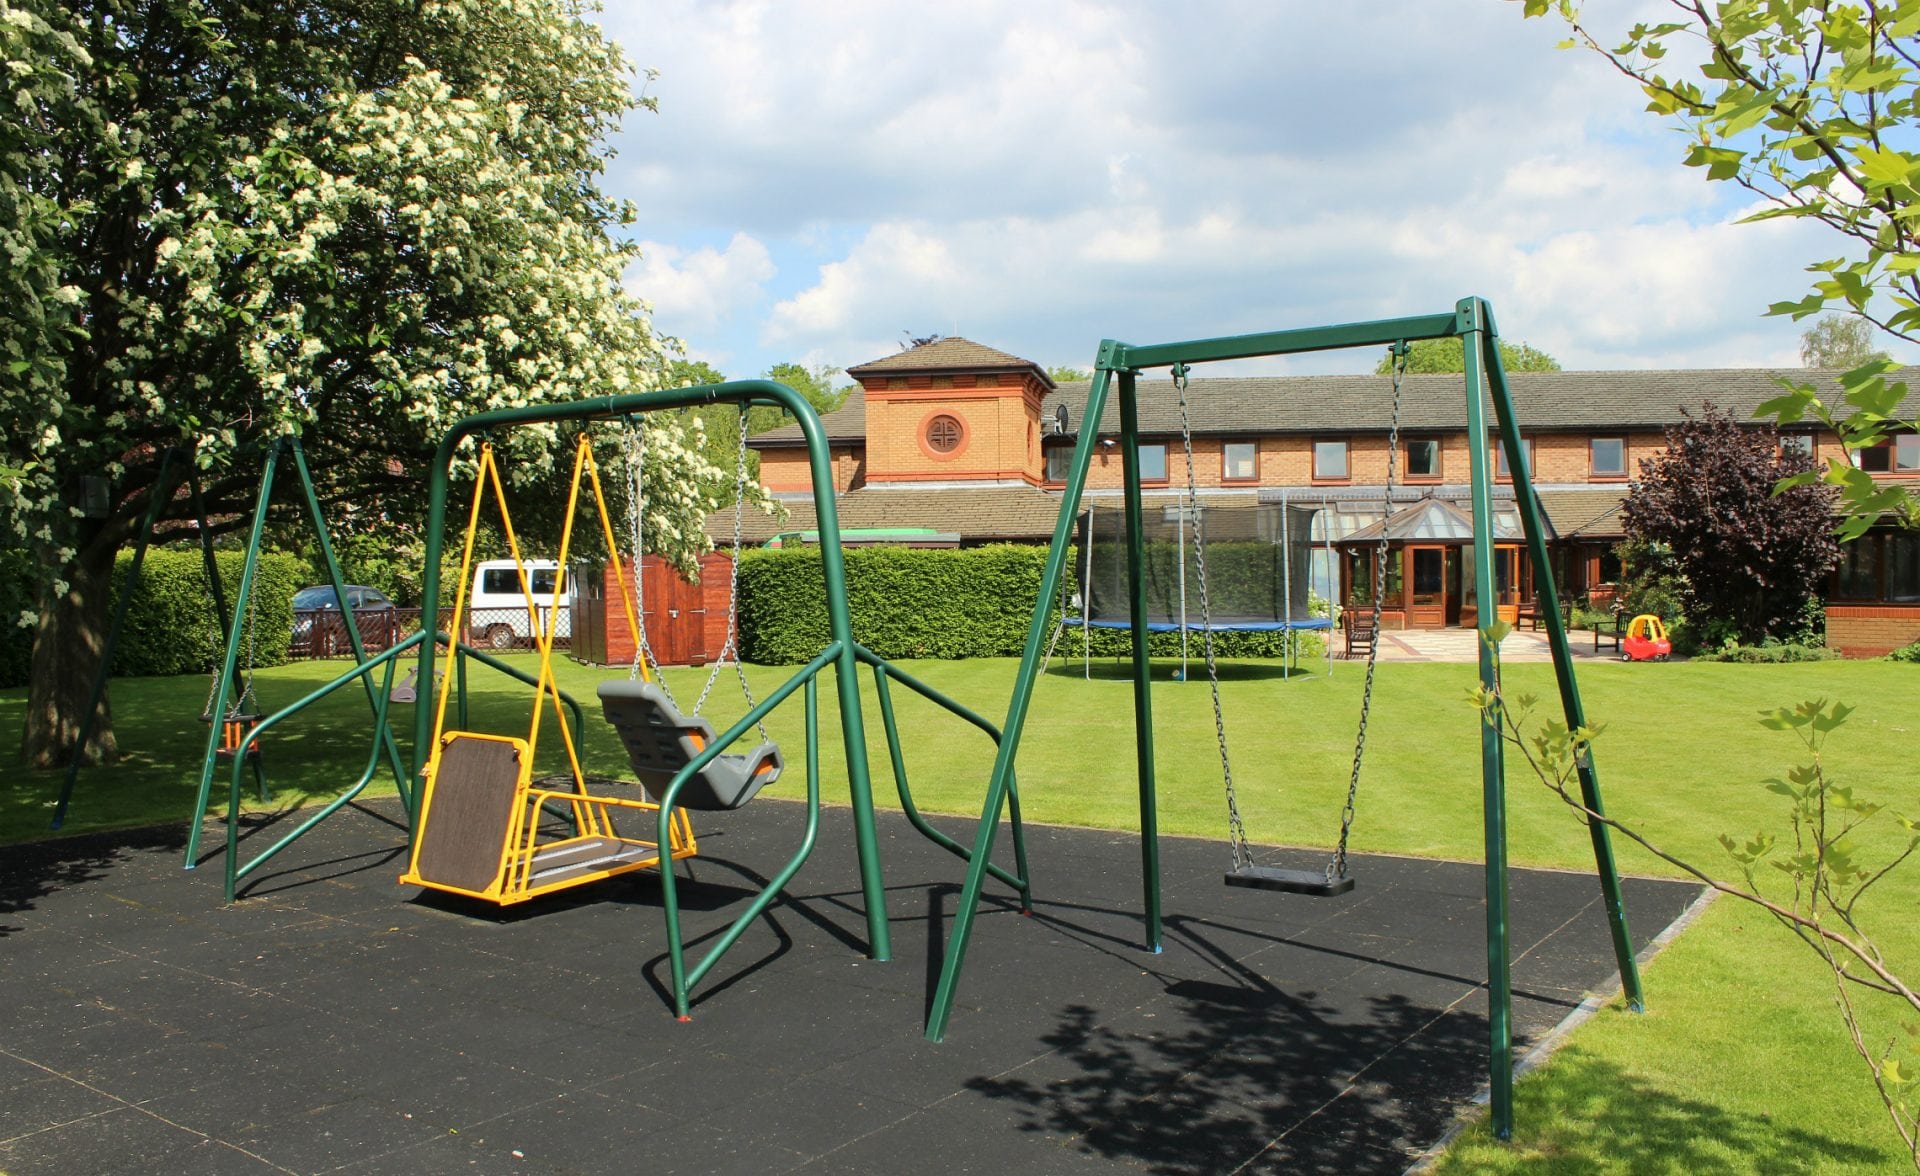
left=587, top=0, right=1901, bottom=377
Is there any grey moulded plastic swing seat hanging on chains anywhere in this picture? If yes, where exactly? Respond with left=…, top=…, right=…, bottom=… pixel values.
left=599, top=682, right=785, bottom=813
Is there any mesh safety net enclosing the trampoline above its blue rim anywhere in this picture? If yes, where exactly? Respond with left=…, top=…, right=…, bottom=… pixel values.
left=1079, top=503, right=1327, bottom=628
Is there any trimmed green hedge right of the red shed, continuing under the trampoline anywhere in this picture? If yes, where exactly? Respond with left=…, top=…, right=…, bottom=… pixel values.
left=739, top=544, right=1325, bottom=665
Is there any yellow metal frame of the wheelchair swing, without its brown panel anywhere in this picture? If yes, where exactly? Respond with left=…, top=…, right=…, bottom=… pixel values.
left=399, top=432, right=699, bottom=905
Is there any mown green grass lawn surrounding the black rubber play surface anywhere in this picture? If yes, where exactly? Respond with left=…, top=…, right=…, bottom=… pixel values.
left=0, top=657, right=1920, bottom=1172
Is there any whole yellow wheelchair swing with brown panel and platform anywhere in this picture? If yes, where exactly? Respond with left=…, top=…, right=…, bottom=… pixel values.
left=399, top=436, right=699, bottom=905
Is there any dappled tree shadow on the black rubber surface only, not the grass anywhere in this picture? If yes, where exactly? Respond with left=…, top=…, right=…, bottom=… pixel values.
left=968, top=980, right=1486, bottom=1174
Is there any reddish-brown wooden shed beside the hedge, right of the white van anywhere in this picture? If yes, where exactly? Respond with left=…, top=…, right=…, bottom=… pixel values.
left=570, top=551, right=733, bottom=665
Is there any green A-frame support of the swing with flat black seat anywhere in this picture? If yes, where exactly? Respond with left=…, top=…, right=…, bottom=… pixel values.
left=925, top=298, right=1644, bottom=1139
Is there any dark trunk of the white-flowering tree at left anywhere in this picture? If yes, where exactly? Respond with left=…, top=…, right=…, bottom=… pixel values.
left=21, top=542, right=117, bottom=769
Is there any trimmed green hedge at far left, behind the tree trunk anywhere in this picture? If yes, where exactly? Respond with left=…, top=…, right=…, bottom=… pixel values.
left=0, top=548, right=311, bottom=686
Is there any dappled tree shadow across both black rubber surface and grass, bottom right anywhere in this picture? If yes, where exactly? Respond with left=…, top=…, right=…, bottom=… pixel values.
left=968, top=980, right=1884, bottom=1174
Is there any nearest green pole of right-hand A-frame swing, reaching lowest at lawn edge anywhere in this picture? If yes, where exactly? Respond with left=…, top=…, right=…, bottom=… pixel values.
left=1451, top=298, right=1513, bottom=1139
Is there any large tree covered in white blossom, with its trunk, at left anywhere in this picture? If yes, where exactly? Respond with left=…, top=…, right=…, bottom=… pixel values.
left=0, top=0, right=714, bottom=767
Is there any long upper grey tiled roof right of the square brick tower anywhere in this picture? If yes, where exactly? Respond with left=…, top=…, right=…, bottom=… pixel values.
left=1041, top=367, right=1920, bottom=436
